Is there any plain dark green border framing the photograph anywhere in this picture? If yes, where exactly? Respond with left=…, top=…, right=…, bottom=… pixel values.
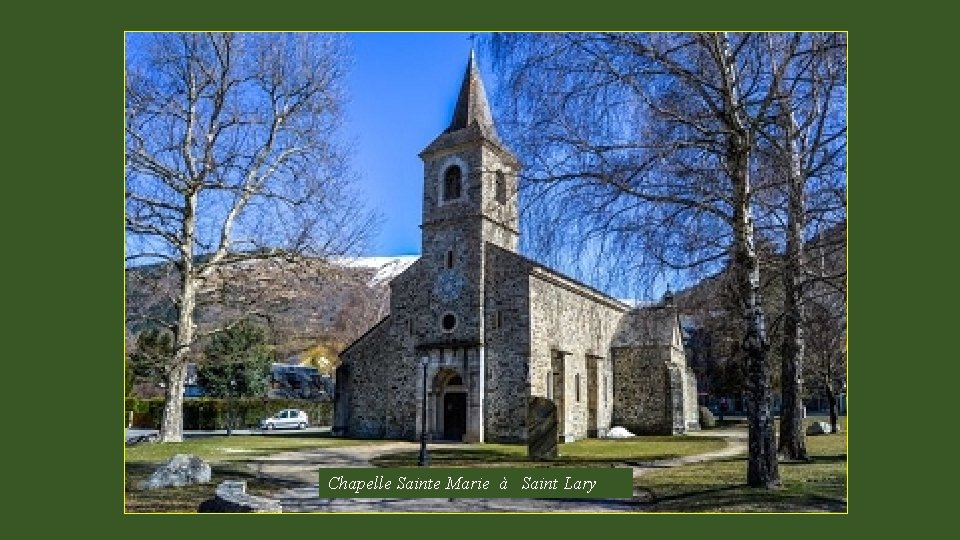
left=13, top=0, right=944, bottom=538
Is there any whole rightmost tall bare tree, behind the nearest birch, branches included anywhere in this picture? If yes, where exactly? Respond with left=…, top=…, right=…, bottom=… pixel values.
left=759, top=33, right=846, bottom=460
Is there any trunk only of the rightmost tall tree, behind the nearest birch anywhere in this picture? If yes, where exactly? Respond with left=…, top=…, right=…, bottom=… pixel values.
left=780, top=105, right=808, bottom=460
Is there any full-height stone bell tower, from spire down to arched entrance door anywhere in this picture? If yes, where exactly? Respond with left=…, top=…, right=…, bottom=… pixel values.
left=415, top=51, right=520, bottom=441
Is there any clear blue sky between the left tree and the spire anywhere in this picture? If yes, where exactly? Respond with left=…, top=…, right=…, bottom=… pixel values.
left=346, top=32, right=480, bottom=255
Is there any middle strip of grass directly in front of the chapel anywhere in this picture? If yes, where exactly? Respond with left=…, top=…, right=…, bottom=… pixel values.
left=372, top=436, right=725, bottom=467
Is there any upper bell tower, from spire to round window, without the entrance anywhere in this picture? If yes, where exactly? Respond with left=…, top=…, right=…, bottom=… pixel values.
left=412, top=51, right=520, bottom=344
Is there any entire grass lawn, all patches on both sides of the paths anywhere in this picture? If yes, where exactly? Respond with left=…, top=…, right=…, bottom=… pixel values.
left=125, top=417, right=847, bottom=512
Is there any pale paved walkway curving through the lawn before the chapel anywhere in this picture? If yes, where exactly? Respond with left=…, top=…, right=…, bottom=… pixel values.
left=251, top=430, right=747, bottom=513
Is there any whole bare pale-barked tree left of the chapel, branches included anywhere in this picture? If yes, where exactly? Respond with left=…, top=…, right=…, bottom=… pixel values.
left=126, top=33, right=373, bottom=442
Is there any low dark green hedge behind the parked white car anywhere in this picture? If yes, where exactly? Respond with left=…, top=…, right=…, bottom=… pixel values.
left=124, top=398, right=333, bottom=429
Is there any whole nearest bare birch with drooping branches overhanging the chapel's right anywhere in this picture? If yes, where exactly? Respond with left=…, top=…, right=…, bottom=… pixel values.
left=492, top=33, right=844, bottom=487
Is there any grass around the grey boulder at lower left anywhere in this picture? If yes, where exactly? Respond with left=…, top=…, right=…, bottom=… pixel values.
left=124, top=433, right=384, bottom=512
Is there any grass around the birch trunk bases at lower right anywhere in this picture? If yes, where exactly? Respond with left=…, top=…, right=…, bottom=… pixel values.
left=634, top=418, right=847, bottom=512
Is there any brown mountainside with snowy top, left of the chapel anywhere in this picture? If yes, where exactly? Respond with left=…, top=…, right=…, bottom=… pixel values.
left=126, top=256, right=418, bottom=364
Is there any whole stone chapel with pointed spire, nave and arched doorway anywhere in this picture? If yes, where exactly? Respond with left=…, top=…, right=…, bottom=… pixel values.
left=333, top=53, right=699, bottom=442
